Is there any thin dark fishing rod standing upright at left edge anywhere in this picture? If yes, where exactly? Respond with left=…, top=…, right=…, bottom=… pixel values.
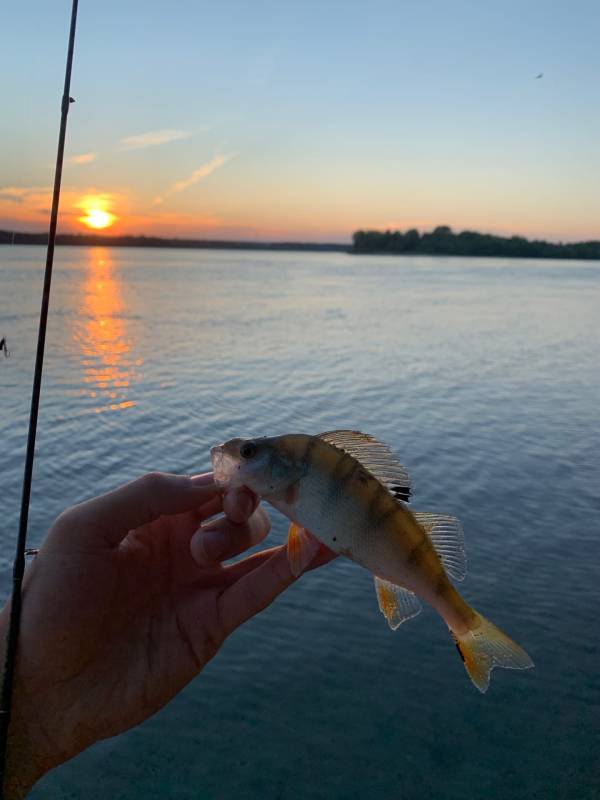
left=0, top=0, right=79, bottom=800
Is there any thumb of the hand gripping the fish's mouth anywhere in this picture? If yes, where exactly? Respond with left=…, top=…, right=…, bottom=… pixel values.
left=52, top=472, right=218, bottom=547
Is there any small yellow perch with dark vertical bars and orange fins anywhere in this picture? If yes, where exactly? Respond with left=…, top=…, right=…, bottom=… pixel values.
left=211, top=430, right=534, bottom=693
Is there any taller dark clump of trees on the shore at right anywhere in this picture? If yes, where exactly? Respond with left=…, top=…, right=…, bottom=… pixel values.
left=352, top=225, right=600, bottom=259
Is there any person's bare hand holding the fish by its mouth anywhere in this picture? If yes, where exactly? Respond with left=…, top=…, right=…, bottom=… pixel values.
left=0, top=473, right=332, bottom=800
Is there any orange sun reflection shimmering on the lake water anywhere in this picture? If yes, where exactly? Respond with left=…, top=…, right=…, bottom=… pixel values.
left=74, top=248, right=143, bottom=413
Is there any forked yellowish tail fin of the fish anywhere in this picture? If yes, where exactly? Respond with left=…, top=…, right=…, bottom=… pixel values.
left=450, top=612, right=533, bottom=693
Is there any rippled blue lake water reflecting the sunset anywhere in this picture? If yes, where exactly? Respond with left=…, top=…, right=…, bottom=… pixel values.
left=0, top=247, right=600, bottom=800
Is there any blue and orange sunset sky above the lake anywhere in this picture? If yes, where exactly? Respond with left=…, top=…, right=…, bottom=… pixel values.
left=0, top=0, right=600, bottom=242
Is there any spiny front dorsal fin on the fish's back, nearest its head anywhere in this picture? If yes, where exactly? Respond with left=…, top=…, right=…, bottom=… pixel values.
left=318, top=431, right=410, bottom=503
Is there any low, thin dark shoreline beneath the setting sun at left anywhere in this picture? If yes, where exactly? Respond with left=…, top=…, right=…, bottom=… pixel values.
left=0, top=230, right=350, bottom=253
